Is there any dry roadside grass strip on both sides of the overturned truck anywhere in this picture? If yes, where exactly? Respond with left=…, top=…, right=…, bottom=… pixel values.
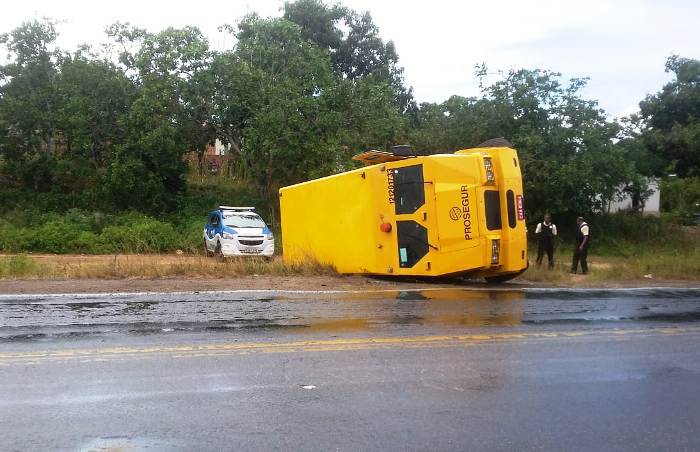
left=0, top=249, right=700, bottom=286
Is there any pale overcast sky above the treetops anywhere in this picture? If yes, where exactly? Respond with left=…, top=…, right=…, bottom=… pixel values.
left=0, top=0, right=700, bottom=116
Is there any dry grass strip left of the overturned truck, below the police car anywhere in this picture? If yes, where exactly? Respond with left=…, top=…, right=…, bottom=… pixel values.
left=0, top=254, right=337, bottom=279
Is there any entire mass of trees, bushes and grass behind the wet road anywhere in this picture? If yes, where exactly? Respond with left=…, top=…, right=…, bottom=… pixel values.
left=0, top=0, right=700, bottom=280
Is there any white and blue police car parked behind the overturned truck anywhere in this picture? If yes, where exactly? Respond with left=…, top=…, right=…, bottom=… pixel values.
left=204, top=206, right=275, bottom=258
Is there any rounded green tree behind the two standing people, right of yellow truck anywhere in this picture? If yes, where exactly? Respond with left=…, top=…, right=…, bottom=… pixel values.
left=485, top=69, right=632, bottom=216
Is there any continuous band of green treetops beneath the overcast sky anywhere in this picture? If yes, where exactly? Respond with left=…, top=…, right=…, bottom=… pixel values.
left=0, top=0, right=700, bottom=221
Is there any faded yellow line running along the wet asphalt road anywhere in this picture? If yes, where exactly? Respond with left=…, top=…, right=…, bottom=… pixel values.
left=0, top=327, right=700, bottom=365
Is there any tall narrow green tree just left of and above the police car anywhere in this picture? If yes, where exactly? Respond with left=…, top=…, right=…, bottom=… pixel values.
left=108, top=24, right=215, bottom=209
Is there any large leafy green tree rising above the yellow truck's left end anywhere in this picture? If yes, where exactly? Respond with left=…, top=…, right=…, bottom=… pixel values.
left=224, top=15, right=338, bottom=195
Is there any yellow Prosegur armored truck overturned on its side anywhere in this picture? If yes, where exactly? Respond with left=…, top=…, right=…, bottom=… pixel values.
left=279, top=139, right=528, bottom=282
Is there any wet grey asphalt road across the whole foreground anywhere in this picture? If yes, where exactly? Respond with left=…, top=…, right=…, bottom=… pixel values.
left=0, top=289, right=700, bottom=451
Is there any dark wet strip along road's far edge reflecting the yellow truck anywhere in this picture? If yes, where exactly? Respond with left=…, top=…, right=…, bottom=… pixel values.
left=0, top=288, right=700, bottom=342
